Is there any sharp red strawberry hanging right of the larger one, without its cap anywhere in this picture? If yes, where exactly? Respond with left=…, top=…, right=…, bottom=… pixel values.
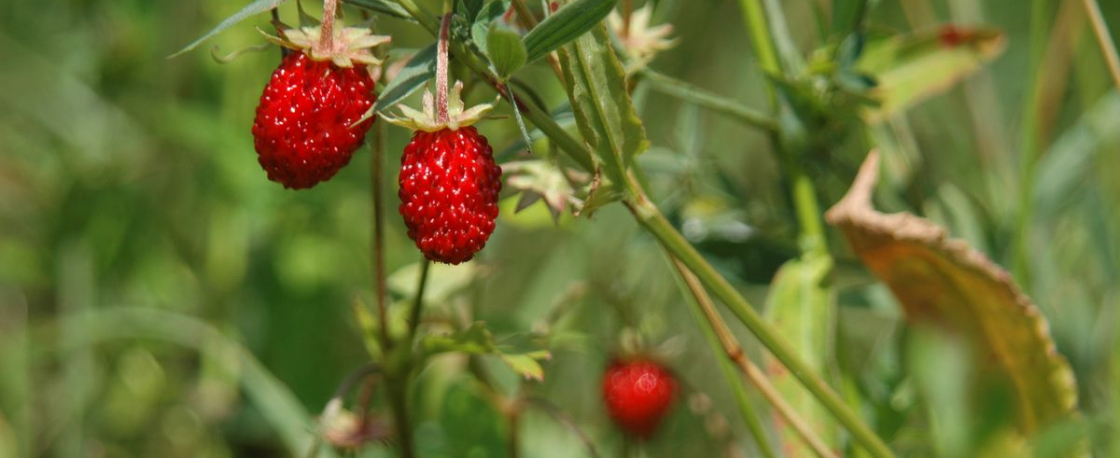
left=399, top=127, right=502, bottom=264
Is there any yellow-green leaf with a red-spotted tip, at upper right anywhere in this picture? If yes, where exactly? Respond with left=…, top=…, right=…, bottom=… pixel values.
left=857, top=26, right=1004, bottom=122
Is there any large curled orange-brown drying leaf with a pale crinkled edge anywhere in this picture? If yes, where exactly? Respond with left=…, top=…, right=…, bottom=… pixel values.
left=825, top=152, right=1077, bottom=445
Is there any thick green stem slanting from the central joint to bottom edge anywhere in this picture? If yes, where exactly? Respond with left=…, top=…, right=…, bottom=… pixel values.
left=626, top=179, right=894, bottom=458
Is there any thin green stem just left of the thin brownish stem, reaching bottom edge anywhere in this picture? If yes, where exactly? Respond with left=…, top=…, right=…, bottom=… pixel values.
left=666, top=257, right=776, bottom=458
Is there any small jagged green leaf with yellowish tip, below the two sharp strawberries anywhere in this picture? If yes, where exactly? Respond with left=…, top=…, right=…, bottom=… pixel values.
left=420, top=321, right=551, bottom=380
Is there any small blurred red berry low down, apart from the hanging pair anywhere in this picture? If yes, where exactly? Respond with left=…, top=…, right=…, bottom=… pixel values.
left=603, top=358, right=676, bottom=439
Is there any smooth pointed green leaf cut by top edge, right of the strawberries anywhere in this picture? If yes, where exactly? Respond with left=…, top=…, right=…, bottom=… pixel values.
left=524, top=0, right=618, bottom=63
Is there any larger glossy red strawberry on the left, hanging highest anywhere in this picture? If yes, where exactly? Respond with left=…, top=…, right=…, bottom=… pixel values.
left=253, top=52, right=377, bottom=189
